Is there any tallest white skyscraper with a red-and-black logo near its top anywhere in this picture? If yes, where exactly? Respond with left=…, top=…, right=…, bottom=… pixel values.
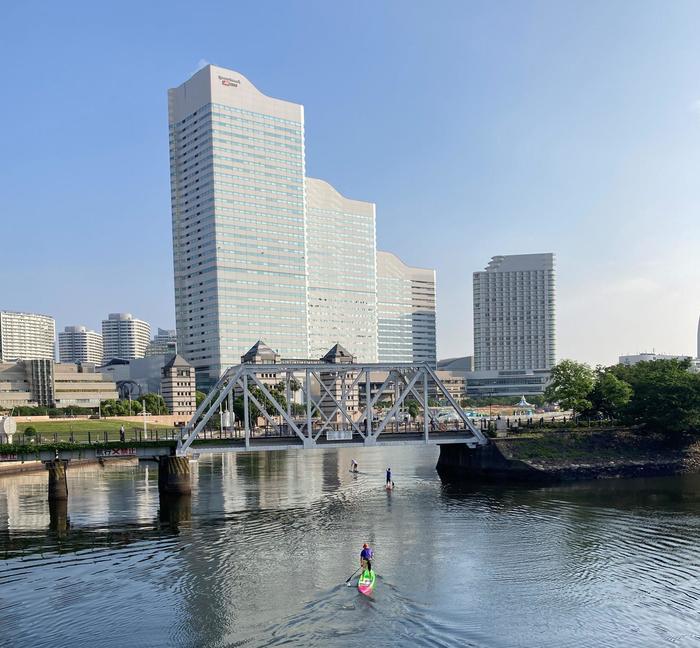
left=168, top=65, right=309, bottom=386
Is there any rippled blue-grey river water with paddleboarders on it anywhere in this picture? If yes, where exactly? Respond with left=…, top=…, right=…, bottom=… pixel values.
left=0, top=448, right=700, bottom=648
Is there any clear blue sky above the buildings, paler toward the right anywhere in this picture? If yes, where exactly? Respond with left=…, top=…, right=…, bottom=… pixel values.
left=0, top=0, right=700, bottom=363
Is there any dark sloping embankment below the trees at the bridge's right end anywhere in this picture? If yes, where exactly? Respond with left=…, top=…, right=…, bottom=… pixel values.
left=437, top=428, right=700, bottom=482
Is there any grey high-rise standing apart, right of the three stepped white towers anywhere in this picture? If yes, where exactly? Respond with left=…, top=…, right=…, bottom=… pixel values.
left=474, top=253, right=555, bottom=372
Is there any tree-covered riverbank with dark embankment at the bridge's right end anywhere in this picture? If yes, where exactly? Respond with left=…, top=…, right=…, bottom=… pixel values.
left=437, top=360, right=700, bottom=482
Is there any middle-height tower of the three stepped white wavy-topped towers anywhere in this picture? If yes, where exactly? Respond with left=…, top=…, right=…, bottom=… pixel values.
left=306, top=178, right=377, bottom=362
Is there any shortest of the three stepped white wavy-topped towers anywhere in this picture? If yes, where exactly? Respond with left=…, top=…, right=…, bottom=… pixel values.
left=377, top=251, right=437, bottom=367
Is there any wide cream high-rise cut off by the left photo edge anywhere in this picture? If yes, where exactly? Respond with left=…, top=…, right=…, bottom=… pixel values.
left=0, top=311, right=56, bottom=362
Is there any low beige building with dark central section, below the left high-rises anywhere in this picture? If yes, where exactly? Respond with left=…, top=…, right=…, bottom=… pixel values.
left=0, top=359, right=117, bottom=409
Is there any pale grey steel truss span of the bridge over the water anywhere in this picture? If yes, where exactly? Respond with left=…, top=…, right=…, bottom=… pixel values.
left=176, top=362, right=488, bottom=456
